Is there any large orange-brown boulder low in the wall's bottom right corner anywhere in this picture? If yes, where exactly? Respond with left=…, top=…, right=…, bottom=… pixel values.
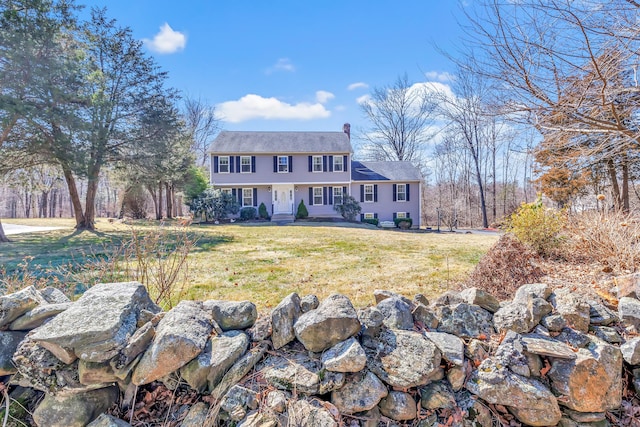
left=548, top=342, right=622, bottom=412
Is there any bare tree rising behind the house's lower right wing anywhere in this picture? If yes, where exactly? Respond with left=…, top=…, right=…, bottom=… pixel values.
left=361, top=74, right=436, bottom=162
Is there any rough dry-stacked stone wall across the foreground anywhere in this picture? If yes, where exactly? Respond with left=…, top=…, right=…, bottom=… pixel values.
left=0, top=276, right=640, bottom=427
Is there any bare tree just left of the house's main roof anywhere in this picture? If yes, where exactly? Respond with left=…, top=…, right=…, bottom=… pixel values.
left=184, top=97, right=220, bottom=167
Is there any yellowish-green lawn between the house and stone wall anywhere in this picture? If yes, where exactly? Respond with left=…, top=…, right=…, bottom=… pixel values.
left=0, top=219, right=497, bottom=308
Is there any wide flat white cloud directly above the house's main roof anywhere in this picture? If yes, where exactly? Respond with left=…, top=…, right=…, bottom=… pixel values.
left=216, top=94, right=331, bottom=123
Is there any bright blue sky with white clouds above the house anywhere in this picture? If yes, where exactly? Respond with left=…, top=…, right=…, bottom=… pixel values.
left=78, top=0, right=463, bottom=133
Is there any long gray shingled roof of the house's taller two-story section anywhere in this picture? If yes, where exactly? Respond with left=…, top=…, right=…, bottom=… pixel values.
left=209, top=131, right=353, bottom=154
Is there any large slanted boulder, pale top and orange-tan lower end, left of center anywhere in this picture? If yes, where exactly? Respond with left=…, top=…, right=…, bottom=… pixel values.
left=131, top=301, right=213, bottom=385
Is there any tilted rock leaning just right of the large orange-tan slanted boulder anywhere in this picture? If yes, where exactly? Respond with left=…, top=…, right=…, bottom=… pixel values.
left=180, top=331, right=249, bottom=392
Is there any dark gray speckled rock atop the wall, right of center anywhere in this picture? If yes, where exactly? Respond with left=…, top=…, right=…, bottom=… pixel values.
left=435, top=303, right=494, bottom=338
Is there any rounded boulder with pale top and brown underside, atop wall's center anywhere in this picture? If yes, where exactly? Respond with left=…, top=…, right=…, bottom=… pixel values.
left=294, top=294, right=361, bottom=352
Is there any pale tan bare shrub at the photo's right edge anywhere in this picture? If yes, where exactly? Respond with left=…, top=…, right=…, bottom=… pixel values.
left=565, top=211, right=640, bottom=273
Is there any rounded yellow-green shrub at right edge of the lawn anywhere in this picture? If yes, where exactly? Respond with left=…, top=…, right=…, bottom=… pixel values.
left=507, top=197, right=566, bottom=256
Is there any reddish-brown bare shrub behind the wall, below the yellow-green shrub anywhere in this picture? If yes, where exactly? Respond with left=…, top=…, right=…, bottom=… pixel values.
left=465, top=234, right=544, bottom=300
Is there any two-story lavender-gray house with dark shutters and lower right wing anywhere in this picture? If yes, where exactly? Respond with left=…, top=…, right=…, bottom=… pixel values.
left=210, top=124, right=422, bottom=227
